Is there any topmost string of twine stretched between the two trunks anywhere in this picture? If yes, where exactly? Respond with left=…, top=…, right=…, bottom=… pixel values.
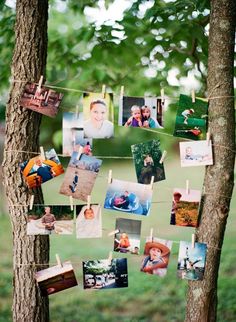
left=12, top=79, right=236, bottom=101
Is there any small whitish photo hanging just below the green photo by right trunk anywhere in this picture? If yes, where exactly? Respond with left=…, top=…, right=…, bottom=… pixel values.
left=179, top=140, right=213, bottom=167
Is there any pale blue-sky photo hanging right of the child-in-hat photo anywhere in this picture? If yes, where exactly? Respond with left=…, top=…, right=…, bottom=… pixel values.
left=177, top=241, right=207, bottom=281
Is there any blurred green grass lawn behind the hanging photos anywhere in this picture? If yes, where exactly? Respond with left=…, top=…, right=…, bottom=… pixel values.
left=0, top=156, right=236, bottom=322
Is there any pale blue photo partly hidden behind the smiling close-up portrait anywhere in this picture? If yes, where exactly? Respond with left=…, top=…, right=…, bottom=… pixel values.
left=62, top=112, right=92, bottom=156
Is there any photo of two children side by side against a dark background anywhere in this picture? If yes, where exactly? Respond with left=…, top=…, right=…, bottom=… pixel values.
left=119, top=96, right=164, bottom=129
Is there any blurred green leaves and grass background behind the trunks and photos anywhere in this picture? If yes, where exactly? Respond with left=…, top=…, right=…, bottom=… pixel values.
left=0, top=0, right=236, bottom=322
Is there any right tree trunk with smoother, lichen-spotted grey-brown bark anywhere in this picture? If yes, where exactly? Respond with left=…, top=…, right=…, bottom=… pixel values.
left=186, top=0, right=236, bottom=322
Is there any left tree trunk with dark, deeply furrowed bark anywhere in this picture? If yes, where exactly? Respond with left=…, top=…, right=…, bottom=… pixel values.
left=3, top=0, right=49, bottom=322
